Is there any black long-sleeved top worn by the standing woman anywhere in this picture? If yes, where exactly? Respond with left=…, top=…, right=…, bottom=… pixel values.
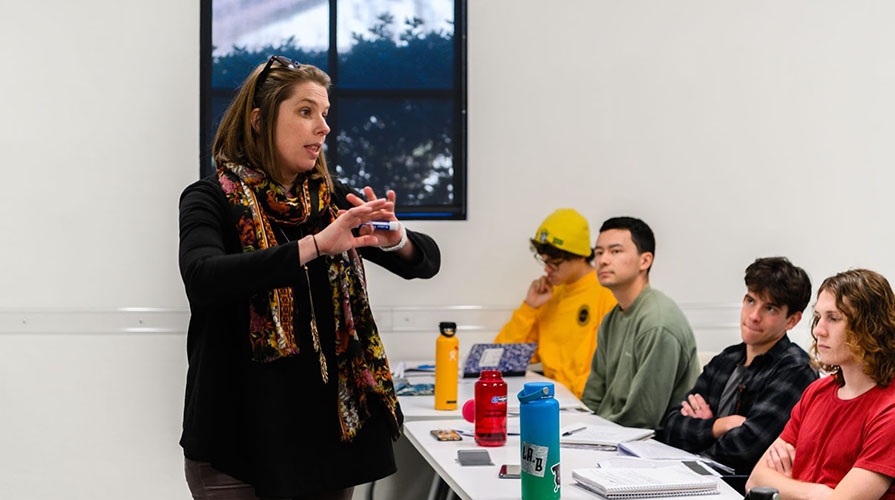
left=180, top=176, right=441, bottom=498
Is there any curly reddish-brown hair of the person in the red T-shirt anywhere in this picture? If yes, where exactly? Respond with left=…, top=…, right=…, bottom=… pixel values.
left=811, top=269, right=895, bottom=387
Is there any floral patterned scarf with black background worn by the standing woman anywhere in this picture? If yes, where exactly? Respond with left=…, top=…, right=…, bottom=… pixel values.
left=217, top=162, right=398, bottom=442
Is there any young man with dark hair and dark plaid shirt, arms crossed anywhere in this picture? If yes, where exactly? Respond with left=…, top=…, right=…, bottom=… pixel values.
left=657, top=257, right=817, bottom=474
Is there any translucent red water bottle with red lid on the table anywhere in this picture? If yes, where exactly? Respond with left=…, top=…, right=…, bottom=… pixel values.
left=475, top=370, right=507, bottom=446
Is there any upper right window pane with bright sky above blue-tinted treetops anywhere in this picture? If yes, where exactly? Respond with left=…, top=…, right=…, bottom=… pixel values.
left=336, top=0, right=454, bottom=89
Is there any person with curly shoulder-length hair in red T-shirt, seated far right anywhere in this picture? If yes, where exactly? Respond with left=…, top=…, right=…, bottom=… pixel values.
left=746, top=269, right=895, bottom=500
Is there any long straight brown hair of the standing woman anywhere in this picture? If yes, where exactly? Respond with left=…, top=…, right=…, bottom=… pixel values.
left=212, top=57, right=332, bottom=188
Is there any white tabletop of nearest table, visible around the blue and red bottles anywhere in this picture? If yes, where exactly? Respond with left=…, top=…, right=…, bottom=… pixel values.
left=404, top=411, right=742, bottom=500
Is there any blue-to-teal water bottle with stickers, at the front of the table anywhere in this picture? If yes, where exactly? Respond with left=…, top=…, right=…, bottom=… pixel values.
left=517, top=382, right=562, bottom=500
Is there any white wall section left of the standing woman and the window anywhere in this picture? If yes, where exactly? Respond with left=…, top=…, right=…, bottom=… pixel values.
left=0, top=0, right=199, bottom=500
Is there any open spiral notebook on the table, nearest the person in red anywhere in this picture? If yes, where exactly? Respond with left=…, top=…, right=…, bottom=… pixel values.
left=572, top=464, right=719, bottom=500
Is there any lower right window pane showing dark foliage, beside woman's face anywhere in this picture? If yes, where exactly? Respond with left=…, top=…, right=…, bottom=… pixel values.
left=328, top=98, right=454, bottom=210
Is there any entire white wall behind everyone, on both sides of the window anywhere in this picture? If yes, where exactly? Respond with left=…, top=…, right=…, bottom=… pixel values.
left=0, top=0, right=895, bottom=499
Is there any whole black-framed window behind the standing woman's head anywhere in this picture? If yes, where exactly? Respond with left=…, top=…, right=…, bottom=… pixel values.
left=200, top=0, right=466, bottom=219
